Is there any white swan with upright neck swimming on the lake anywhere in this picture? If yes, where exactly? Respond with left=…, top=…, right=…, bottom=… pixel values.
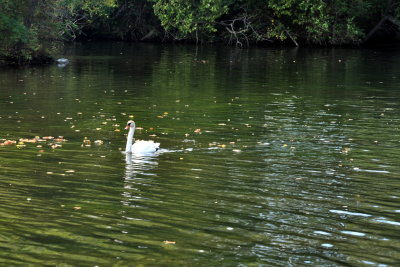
left=125, top=121, right=160, bottom=154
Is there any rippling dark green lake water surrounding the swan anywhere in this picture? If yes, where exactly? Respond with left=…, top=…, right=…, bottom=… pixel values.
left=0, top=43, right=400, bottom=266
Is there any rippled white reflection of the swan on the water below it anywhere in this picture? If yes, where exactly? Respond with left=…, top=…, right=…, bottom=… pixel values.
left=122, top=153, right=158, bottom=207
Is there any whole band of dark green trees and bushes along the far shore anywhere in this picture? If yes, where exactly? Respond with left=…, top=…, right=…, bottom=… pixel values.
left=0, top=0, right=400, bottom=65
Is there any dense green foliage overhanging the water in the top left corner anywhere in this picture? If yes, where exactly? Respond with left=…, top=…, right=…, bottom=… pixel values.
left=0, top=0, right=114, bottom=64
